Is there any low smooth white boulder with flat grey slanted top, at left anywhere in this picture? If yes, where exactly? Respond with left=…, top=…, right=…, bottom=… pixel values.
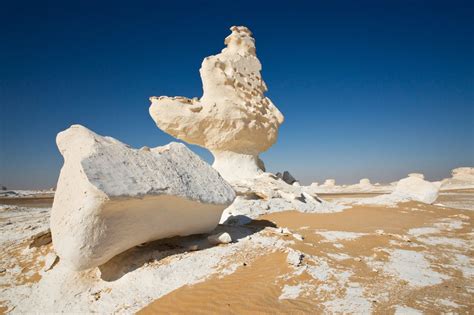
left=51, top=125, right=235, bottom=270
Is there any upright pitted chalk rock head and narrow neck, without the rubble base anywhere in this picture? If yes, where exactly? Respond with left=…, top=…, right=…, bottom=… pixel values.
left=150, top=26, right=284, bottom=181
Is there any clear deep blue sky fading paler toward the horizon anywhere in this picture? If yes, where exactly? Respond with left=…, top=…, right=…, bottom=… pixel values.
left=0, top=0, right=474, bottom=188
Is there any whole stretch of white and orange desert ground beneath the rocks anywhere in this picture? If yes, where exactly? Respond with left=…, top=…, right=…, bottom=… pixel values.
left=0, top=190, right=474, bottom=314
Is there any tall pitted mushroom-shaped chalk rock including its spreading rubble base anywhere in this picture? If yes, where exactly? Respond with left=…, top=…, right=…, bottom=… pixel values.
left=150, top=26, right=341, bottom=217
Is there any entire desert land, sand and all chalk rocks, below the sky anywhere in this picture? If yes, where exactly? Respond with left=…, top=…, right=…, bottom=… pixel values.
left=0, top=26, right=474, bottom=314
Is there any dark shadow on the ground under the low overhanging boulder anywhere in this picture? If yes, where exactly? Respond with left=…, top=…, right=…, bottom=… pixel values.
left=99, top=219, right=276, bottom=282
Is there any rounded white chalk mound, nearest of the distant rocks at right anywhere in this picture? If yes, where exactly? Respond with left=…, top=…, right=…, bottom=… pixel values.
left=392, top=174, right=440, bottom=204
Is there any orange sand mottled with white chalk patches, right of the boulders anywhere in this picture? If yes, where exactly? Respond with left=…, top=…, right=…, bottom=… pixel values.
left=141, top=202, right=474, bottom=314
